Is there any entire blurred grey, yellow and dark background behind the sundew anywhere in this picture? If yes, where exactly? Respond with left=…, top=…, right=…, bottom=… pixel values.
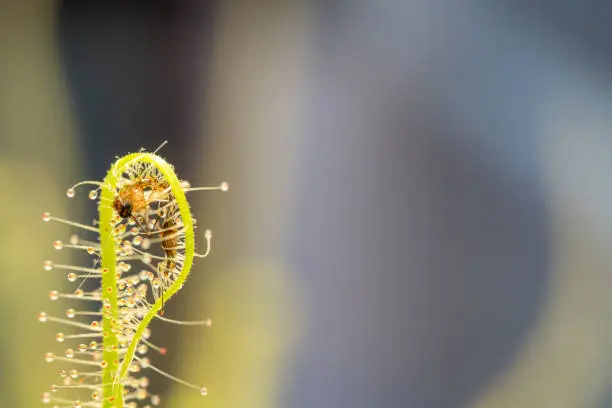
left=0, top=0, right=612, bottom=408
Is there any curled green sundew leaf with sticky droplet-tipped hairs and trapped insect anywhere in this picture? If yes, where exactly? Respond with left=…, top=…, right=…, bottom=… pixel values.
left=38, top=145, right=228, bottom=408
